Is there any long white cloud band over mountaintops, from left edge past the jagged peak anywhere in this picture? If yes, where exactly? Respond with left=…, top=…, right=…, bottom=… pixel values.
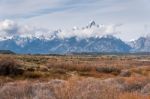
left=0, top=19, right=121, bottom=39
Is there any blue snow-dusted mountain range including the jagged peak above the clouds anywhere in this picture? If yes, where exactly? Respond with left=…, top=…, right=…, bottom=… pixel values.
left=0, top=21, right=150, bottom=54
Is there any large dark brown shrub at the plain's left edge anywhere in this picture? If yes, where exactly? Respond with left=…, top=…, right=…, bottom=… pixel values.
left=0, top=58, right=24, bottom=75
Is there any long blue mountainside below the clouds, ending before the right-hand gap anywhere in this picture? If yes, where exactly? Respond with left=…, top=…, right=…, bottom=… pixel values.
left=0, top=36, right=130, bottom=53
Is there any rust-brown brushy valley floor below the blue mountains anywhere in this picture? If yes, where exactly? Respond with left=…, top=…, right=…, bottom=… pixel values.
left=0, top=55, right=150, bottom=99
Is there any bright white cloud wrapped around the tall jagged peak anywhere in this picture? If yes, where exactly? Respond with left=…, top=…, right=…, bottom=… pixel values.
left=57, top=23, right=121, bottom=39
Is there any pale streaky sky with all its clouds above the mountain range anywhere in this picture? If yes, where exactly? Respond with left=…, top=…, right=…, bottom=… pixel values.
left=0, top=0, right=150, bottom=41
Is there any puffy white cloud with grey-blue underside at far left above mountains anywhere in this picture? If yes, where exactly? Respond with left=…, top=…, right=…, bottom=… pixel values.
left=0, top=19, right=58, bottom=39
